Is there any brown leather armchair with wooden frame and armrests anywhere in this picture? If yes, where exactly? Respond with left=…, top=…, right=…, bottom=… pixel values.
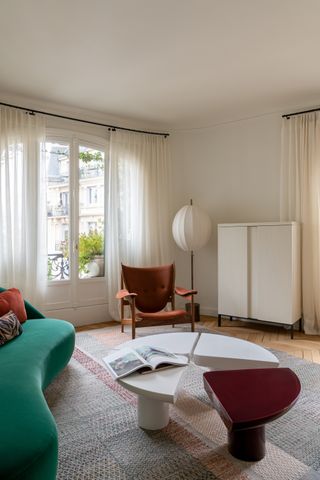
left=116, top=264, right=197, bottom=338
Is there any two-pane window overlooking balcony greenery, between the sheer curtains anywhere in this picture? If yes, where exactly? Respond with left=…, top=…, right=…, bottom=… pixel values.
left=46, top=138, right=105, bottom=281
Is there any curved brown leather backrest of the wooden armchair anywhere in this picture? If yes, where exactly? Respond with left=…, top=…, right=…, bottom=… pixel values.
left=122, top=264, right=175, bottom=313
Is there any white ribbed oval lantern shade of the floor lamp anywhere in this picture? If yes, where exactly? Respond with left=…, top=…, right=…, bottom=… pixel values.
left=172, top=205, right=211, bottom=252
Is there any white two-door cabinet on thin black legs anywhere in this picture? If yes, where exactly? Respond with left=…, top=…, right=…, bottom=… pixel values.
left=218, top=222, right=301, bottom=336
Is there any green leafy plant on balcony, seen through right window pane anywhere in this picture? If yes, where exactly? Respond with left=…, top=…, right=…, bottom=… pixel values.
left=79, top=230, right=104, bottom=277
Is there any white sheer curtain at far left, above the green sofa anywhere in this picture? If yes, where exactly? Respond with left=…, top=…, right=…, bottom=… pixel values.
left=0, top=106, right=46, bottom=303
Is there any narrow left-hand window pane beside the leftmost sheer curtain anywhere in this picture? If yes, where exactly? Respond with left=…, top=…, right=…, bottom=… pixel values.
left=46, top=142, right=70, bottom=280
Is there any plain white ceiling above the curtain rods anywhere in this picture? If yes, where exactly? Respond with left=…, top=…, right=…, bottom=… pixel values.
left=0, top=0, right=320, bottom=129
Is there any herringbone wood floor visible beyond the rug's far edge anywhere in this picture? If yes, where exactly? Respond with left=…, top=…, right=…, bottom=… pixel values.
left=77, top=315, right=320, bottom=363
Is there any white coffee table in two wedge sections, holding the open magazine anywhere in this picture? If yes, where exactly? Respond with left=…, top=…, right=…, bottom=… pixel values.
left=117, top=332, right=279, bottom=430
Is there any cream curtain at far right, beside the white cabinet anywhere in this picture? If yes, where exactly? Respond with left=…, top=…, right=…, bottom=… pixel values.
left=280, top=112, right=320, bottom=334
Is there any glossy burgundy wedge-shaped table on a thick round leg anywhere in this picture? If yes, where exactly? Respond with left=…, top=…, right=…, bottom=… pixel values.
left=203, top=368, right=301, bottom=461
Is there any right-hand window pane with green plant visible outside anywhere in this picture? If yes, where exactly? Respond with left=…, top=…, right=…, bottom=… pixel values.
left=78, top=146, right=105, bottom=278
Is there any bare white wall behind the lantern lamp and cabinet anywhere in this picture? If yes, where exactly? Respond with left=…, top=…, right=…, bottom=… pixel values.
left=170, top=115, right=281, bottom=314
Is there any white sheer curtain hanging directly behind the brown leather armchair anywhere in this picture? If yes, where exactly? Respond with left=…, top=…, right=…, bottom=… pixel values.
left=106, top=131, right=173, bottom=319
